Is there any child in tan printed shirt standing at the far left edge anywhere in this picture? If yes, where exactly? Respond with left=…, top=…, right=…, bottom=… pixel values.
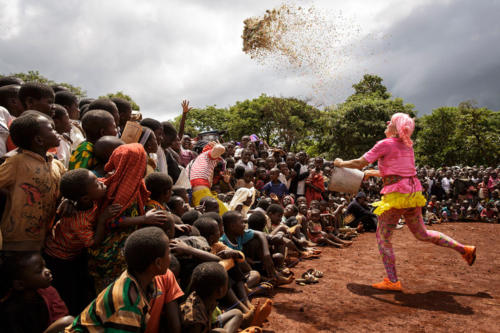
left=0, top=111, right=65, bottom=251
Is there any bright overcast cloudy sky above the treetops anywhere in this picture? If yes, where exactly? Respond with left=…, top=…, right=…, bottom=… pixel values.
left=0, top=0, right=500, bottom=120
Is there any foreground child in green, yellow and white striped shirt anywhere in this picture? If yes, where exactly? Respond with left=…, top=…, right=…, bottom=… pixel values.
left=65, top=227, right=170, bottom=333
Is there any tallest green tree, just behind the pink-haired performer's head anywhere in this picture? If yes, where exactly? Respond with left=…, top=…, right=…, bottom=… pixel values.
left=315, top=75, right=417, bottom=159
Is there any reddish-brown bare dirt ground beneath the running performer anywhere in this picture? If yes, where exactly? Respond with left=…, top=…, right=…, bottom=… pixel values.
left=264, top=223, right=500, bottom=333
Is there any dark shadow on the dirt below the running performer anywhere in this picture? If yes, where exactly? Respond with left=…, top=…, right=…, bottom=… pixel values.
left=347, top=283, right=493, bottom=315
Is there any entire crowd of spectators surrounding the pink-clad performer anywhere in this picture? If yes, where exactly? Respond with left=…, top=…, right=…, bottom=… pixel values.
left=0, top=77, right=499, bottom=332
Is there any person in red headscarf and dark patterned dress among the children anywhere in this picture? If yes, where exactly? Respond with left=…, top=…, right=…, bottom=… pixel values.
left=89, top=143, right=167, bottom=293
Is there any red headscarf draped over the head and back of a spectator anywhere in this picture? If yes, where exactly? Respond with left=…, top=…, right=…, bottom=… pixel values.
left=102, top=143, right=150, bottom=216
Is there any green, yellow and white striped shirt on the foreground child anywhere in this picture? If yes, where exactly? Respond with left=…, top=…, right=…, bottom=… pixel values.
left=64, top=271, right=149, bottom=333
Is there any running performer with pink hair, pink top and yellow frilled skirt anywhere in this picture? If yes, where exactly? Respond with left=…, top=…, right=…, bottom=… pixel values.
left=334, top=113, right=476, bottom=290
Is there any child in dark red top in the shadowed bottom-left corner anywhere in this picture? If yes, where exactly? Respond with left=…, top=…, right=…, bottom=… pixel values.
left=0, top=251, right=73, bottom=333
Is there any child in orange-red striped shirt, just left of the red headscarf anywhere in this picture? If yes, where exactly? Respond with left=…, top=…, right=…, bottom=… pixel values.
left=44, top=169, right=121, bottom=315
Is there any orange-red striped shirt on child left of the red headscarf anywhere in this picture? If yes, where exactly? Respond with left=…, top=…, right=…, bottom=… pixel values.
left=45, top=203, right=98, bottom=260
